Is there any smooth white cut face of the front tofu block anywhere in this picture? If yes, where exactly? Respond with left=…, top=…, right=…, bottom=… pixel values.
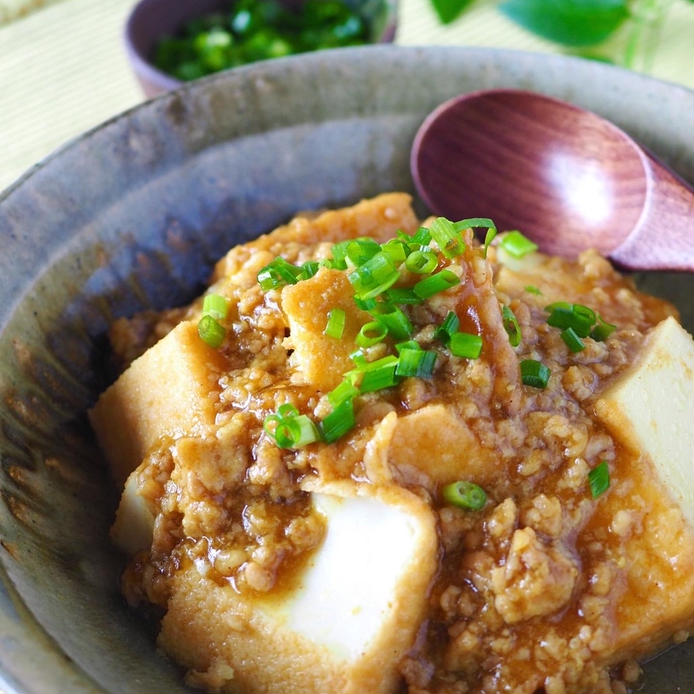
left=271, top=494, right=436, bottom=660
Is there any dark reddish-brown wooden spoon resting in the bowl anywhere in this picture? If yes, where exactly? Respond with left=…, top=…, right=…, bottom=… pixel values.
left=411, top=90, right=694, bottom=271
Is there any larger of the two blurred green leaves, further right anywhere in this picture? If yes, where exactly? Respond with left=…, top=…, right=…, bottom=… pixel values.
left=499, top=0, right=629, bottom=46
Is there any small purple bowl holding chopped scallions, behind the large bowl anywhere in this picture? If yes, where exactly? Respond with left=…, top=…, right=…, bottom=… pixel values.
left=125, top=0, right=398, bottom=98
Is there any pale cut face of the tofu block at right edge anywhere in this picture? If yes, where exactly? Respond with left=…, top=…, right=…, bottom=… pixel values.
left=595, top=318, right=694, bottom=528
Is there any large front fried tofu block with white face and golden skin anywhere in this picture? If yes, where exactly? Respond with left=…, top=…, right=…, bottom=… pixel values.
left=159, top=482, right=437, bottom=694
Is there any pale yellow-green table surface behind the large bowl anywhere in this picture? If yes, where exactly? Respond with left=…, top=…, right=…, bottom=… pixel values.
left=0, top=0, right=694, bottom=190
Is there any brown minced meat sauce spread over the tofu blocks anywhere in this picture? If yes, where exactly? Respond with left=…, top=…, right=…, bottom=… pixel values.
left=94, top=194, right=688, bottom=694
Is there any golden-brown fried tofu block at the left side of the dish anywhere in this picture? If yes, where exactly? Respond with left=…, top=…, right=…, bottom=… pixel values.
left=89, top=321, right=225, bottom=486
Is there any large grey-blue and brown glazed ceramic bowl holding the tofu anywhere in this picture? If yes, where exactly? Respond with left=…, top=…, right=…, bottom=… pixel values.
left=0, top=46, right=694, bottom=694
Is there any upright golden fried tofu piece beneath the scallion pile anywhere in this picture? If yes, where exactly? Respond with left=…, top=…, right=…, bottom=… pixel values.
left=282, top=268, right=372, bottom=392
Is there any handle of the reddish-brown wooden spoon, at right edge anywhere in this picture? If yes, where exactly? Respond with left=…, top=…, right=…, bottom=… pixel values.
left=610, top=152, right=694, bottom=272
